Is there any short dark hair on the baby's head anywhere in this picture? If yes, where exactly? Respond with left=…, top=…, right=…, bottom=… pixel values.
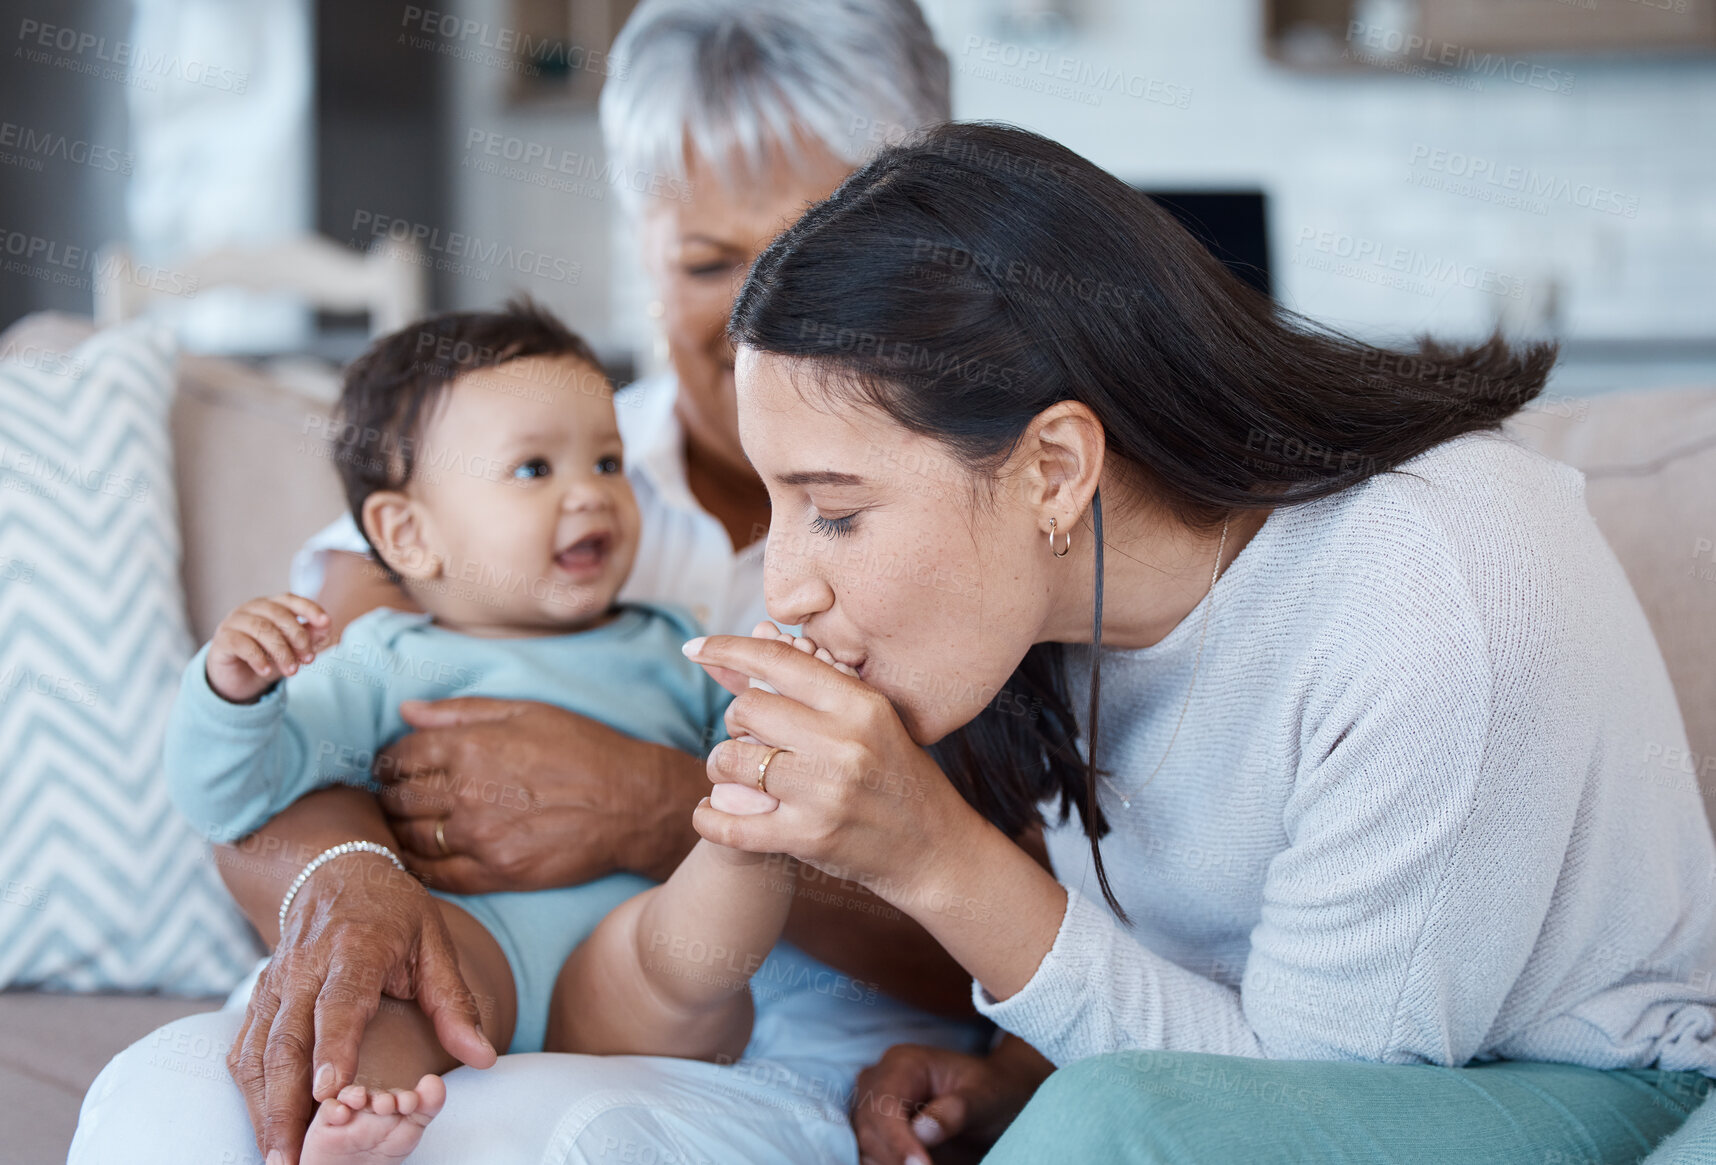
left=331, top=295, right=606, bottom=582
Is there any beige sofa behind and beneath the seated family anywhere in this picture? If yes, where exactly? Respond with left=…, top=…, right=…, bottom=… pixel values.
left=0, top=314, right=1716, bottom=1165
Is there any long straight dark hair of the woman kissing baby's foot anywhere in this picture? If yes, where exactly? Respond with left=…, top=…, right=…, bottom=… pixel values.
left=729, top=124, right=1555, bottom=918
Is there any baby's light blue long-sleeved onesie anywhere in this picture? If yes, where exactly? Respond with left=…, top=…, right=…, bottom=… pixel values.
left=166, top=604, right=729, bottom=1052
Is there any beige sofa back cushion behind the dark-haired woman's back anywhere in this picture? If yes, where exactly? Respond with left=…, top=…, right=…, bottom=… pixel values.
left=1508, top=388, right=1716, bottom=824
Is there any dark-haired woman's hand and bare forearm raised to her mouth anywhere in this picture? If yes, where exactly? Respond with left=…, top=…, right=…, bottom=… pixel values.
left=685, top=635, right=1067, bottom=999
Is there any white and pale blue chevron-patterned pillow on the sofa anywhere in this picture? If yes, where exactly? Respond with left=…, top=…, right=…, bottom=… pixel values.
left=0, top=323, right=259, bottom=995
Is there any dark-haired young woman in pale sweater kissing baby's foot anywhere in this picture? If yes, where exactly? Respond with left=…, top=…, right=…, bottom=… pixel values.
left=688, top=125, right=1716, bottom=1165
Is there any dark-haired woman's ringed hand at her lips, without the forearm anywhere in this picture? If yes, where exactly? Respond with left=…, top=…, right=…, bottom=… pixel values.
left=686, top=635, right=983, bottom=904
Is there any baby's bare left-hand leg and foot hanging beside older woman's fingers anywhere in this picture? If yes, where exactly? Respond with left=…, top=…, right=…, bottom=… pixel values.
left=302, top=901, right=518, bottom=1165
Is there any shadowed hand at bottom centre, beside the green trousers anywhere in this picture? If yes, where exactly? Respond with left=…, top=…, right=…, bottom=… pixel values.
left=853, top=1036, right=1054, bottom=1165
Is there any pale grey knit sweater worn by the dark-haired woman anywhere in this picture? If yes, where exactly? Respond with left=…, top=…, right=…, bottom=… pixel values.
left=973, top=436, right=1716, bottom=1076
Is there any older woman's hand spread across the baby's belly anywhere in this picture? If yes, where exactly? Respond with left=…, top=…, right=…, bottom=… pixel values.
left=374, top=697, right=702, bottom=894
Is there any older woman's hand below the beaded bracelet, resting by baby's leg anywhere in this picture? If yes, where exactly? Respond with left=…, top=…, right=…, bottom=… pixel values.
left=227, top=853, right=494, bottom=1163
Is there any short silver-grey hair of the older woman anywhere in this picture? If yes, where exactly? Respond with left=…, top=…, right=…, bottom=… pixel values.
left=601, top=0, right=952, bottom=202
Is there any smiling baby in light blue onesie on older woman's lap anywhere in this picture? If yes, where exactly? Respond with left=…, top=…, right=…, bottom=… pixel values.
left=166, top=302, right=789, bottom=1165
